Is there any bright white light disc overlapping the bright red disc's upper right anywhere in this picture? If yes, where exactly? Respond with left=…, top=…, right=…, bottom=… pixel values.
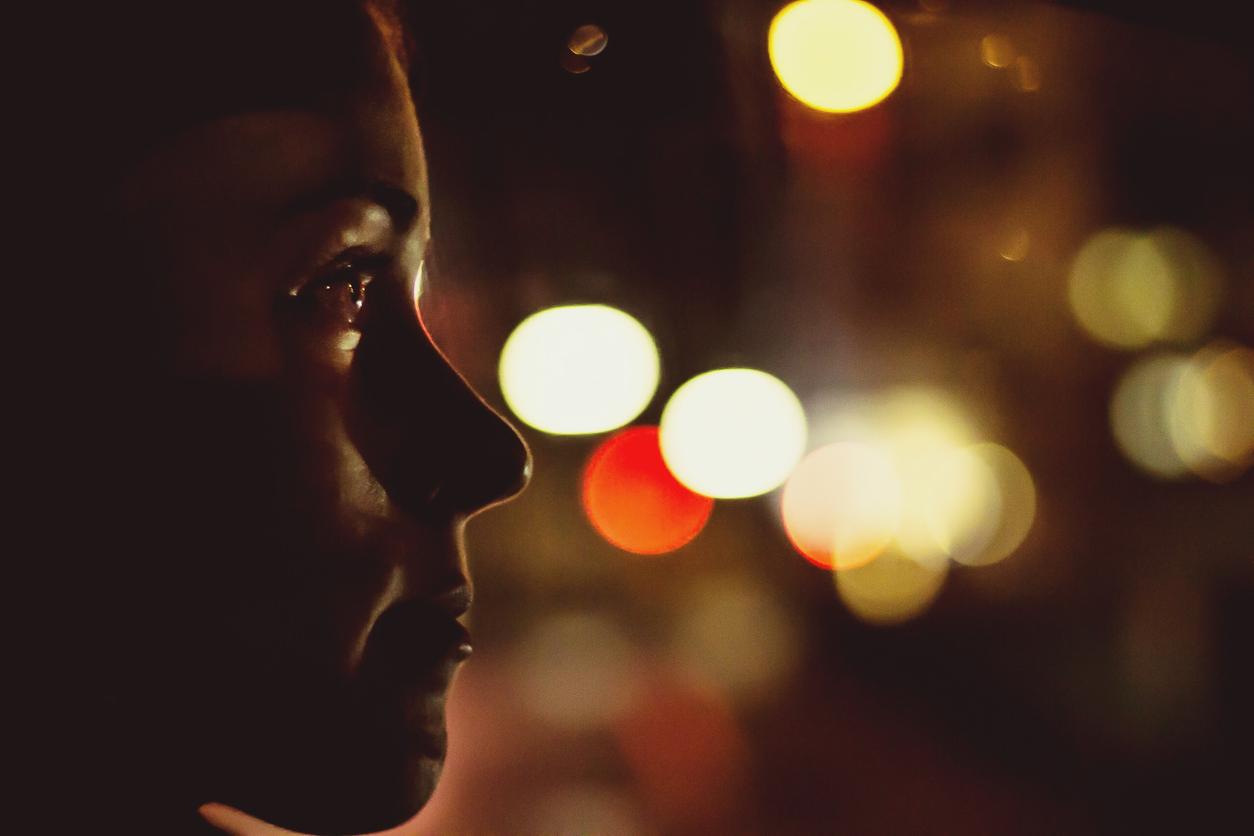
left=661, top=368, right=805, bottom=499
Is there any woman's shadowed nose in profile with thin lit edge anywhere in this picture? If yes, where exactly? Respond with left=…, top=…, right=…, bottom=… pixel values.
left=349, top=273, right=530, bottom=524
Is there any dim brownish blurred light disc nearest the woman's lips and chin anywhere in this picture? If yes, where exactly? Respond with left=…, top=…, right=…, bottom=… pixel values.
left=517, top=613, right=640, bottom=729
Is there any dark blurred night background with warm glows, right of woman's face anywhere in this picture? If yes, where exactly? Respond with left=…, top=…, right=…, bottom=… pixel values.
left=356, top=0, right=1254, bottom=836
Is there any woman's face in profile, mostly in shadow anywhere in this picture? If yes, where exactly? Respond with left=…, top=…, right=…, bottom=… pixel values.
left=110, top=14, right=528, bottom=832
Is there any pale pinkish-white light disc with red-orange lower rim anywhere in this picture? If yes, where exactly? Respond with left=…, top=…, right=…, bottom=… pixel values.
left=780, top=441, right=902, bottom=569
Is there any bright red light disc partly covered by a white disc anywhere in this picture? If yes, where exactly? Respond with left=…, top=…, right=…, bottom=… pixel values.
left=583, top=426, right=714, bottom=554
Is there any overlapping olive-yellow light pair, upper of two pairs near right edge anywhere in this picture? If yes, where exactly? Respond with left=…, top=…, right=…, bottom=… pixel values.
left=1067, top=227, right=1223, bottom=348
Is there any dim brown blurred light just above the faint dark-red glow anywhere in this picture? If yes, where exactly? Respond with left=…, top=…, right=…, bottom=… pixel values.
left=675, top=575, right=801, bottom=703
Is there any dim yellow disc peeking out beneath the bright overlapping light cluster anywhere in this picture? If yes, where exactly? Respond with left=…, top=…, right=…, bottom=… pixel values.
left=835, top=549, right=949, bottom=625
